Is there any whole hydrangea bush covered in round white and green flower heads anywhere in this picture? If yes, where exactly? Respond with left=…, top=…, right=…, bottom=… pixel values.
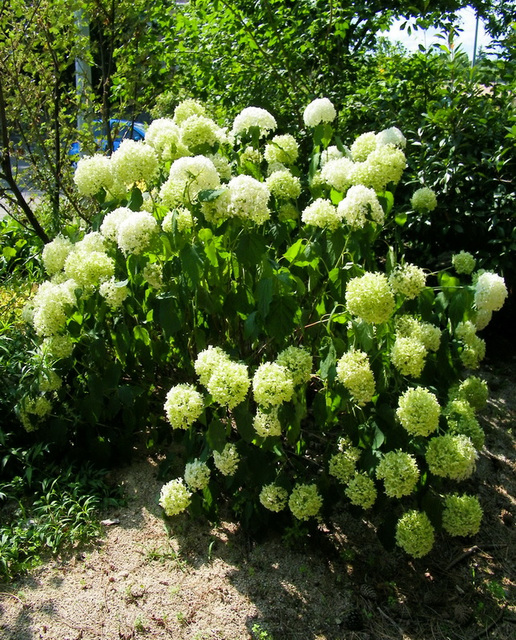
left=20, top=98, right=507, bottom=557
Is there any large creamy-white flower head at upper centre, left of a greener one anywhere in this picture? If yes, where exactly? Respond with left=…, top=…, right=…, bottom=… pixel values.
left=228, top=175, right=271, bottom=225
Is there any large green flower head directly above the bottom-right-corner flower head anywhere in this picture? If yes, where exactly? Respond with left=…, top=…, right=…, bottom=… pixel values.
left=426, top=434, right=477, bottom=480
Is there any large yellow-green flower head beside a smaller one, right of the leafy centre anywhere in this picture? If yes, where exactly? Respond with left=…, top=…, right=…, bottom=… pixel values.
left=346, top=272, right=395, bottom=324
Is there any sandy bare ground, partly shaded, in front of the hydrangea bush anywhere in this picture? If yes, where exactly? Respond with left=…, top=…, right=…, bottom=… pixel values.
left=0, top=366, right=516, bottom=640
